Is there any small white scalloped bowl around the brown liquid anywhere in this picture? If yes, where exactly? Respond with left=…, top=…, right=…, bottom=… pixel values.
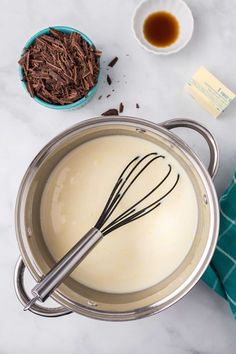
left=132, top=0, right=194, bottom=55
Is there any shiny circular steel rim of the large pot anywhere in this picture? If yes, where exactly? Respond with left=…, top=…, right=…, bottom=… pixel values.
left=15, top=116, right=219, bottom=321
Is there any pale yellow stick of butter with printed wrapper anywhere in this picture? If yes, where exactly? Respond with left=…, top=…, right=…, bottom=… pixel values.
left=185, top=66, right=236, bottom=118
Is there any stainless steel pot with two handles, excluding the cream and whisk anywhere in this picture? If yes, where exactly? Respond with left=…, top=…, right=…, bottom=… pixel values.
left=15, top=117, right=219, bottom=321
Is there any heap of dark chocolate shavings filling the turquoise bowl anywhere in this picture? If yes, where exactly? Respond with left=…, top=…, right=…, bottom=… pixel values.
left=19, top=28, right=101, bottom=105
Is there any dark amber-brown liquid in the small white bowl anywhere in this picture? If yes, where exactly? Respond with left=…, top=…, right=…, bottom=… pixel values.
left=143, top=11, right=179, bottom=47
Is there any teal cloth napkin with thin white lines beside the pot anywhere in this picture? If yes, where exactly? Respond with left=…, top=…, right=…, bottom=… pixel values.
left=202, top=172, right=236, bottom=319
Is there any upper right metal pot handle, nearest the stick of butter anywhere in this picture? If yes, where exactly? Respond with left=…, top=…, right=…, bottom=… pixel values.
left=160, top=118, right=219, bottom=179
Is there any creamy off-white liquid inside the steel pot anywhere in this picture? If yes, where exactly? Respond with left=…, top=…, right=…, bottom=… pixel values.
left=41, top=135, right=198, bottom=293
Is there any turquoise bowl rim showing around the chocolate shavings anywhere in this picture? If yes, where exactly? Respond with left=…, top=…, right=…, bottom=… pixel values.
left=19, top=26, right=101, bottom=111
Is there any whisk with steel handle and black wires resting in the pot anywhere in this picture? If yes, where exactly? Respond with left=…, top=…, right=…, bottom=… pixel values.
left=24, top=152, right=179, bottom=310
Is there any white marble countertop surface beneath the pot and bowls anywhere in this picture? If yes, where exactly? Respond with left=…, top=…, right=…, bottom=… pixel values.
left=0, top=0, right=236, bottom=354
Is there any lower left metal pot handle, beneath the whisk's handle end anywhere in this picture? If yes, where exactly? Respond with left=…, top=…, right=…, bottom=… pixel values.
left=14, top=257, right=72, bottom=317
